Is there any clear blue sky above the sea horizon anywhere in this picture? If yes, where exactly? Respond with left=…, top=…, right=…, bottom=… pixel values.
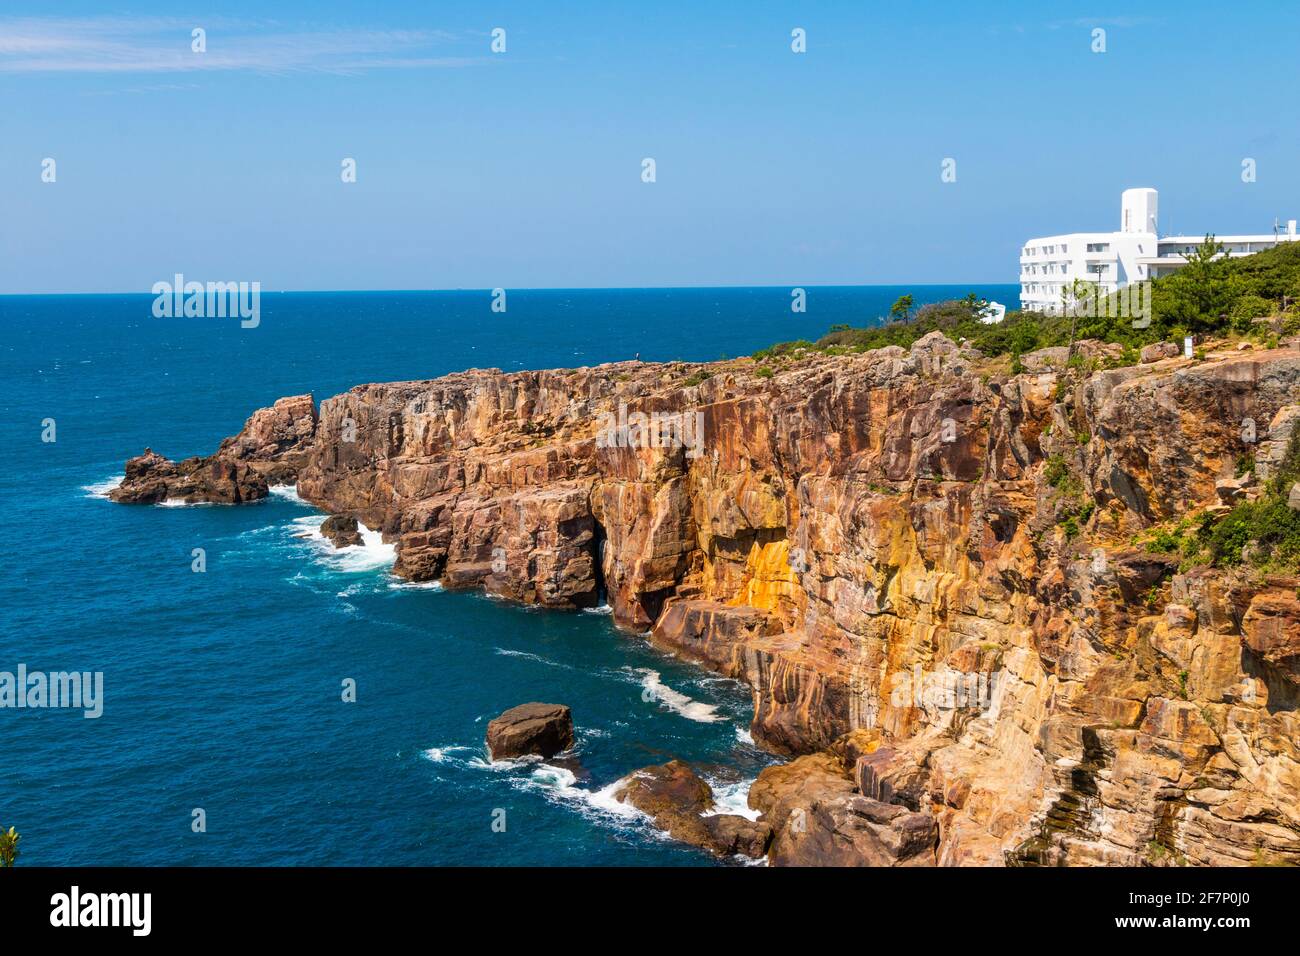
left=0, top=0, right=1300, bottom=293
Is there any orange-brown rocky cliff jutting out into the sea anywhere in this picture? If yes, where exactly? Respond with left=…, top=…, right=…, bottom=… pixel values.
left=114, top=333, right=1300, bottom=865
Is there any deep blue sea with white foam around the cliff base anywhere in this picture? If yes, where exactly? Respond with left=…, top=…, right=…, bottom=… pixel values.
left=0, top=286, right=1018, bottom=865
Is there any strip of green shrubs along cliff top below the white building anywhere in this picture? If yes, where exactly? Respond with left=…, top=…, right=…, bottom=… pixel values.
left=754, top=242, right=1300, bottom=362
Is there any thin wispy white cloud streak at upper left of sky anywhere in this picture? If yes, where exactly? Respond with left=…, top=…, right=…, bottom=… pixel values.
left=0, top=17, right=488, bottom=73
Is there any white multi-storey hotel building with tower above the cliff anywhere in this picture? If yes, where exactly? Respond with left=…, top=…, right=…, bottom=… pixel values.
left=1021, top=189, right=1300, bottom=312
